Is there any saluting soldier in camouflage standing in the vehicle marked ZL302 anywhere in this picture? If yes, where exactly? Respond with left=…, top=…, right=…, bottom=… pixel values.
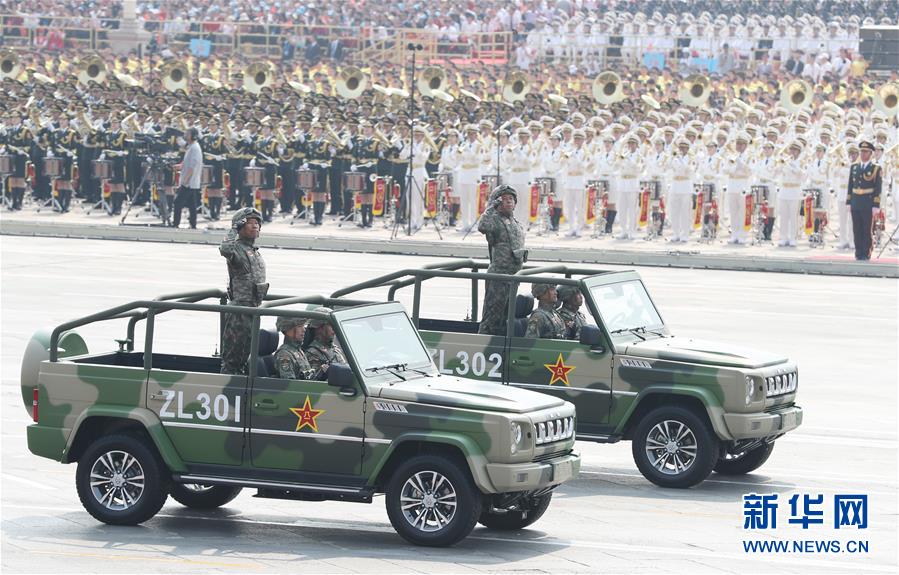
left=478, top=188, right=527, bottom=335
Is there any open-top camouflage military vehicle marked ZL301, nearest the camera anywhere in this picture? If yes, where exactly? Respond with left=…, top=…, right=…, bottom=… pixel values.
left=21, top=291, right=580, bottom=545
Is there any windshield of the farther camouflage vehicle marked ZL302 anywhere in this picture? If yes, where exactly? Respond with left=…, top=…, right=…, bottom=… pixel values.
left=590, top=280, right=664, bottom=334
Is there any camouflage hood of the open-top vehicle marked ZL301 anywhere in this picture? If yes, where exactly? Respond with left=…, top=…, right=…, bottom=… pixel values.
left=378, top=375, right=565, bottom=413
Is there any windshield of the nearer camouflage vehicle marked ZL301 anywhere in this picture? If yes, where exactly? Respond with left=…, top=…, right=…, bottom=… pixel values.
left=340, top=312, right=433, bottom=377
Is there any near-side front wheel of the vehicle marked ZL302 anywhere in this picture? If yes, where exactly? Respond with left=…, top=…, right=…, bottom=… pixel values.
left=631, top=406, right=718, bottom=489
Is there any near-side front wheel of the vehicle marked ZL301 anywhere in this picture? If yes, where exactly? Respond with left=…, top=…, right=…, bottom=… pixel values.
left=386, top=455, right=481, bottom=547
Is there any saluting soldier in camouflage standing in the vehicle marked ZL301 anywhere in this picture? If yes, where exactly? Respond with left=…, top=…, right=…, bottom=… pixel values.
left=219, top=208, right=268, bottom=375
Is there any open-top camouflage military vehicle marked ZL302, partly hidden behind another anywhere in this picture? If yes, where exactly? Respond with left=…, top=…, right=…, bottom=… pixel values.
left=332, top=260, right=802, bottom=487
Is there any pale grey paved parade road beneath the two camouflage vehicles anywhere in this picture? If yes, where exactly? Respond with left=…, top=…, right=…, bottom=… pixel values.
left=0, top=237, right=899, bottom=573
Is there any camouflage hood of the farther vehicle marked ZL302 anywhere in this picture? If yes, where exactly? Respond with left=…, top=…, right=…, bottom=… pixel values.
left=624, top=336, right=789, bottom=369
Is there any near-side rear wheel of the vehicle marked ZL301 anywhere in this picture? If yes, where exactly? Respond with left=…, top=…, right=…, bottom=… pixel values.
left=75, top=435, right=169, bottom=525
